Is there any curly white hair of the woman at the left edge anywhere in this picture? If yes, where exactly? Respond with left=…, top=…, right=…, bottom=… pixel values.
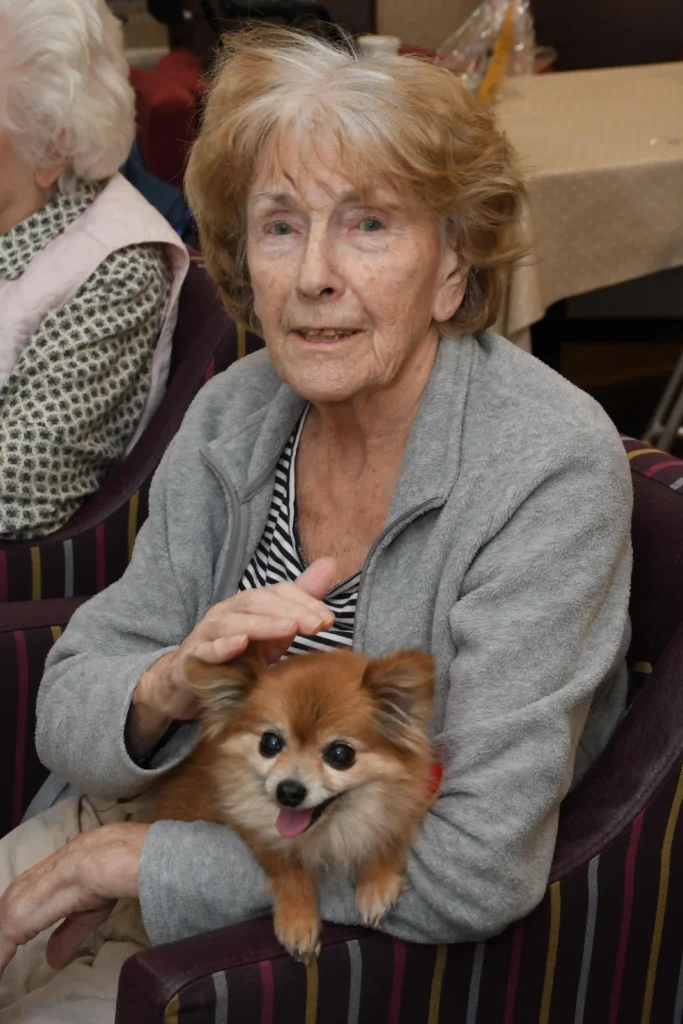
left=0, top=0, right=135, bottom=190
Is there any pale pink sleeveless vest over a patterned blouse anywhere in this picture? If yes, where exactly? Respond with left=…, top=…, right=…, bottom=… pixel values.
left=0, top=174, right=189, bottom=452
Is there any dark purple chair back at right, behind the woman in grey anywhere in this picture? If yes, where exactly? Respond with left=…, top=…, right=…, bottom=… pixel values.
left=551, top=437, right=683, bottom=880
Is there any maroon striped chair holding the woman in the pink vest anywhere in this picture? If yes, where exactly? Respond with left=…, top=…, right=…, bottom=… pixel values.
left=0, top=259, right=263, bottom=604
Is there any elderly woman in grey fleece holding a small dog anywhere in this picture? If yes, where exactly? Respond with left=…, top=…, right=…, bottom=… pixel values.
left=0, top=24, right=631, bottom=1021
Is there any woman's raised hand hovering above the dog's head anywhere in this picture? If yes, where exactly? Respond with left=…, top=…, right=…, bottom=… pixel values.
left=128, top=558, right=337, bottom=758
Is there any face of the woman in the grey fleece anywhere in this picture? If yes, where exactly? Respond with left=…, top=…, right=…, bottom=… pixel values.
left=247, top=138, right=467, bottom=402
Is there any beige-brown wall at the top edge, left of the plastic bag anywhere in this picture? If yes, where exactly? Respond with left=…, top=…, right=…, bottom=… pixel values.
left=377, top=0, right=477, bottom=50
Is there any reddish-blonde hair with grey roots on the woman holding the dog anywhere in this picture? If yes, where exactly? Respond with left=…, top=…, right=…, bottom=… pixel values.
left=185, top=27, right=524, bottom=333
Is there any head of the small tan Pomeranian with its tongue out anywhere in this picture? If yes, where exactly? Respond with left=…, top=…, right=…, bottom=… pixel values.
left=185, top=651, right=433, bottom=846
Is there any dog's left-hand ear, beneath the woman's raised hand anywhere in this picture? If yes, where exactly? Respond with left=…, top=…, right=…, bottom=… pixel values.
left=186, top=653, right=265, bottom=725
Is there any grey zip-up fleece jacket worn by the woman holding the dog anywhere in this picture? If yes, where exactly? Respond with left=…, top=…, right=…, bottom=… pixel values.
left=37, top=334, right=632, bottom=942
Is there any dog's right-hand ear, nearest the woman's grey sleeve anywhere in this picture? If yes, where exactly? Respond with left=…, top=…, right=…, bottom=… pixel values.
left=362, top=650, right=434, bottom=750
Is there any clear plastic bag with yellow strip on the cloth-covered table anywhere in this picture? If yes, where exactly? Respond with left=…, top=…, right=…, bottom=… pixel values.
left=436, top=0, right=536, bottom=102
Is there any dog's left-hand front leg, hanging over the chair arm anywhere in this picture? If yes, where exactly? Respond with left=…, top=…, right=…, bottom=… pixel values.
left=264, top=862, right=321, bottom=964
